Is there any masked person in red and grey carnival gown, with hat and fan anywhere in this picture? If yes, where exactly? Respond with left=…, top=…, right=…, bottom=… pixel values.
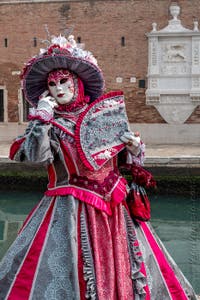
left=0, top=36, right=196, bottom=300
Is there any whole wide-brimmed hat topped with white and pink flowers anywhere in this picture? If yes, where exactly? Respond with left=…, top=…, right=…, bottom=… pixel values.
left=21, top=35, right=104, bottom=107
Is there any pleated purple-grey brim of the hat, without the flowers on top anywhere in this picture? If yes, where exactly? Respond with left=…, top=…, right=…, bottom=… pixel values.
left=23, top=54, right=104, bottom=107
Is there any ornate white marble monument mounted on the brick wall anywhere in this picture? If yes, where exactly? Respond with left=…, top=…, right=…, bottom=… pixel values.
left=146, top=4, right=200, bottom=124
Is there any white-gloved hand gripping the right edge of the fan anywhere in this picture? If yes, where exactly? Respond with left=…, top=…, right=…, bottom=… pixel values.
left=120, top=131, right=140, bottom=156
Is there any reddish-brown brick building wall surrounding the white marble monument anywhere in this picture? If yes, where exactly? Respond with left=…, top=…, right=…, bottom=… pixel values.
left=0, top=0, right=200, bottom=123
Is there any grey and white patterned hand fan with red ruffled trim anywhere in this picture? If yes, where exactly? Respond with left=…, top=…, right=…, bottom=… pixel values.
left=75, top=92, right=128, bottom=170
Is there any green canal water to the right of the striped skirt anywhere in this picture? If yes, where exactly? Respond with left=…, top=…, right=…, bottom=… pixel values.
left=151, top=194, right=200, bottom=294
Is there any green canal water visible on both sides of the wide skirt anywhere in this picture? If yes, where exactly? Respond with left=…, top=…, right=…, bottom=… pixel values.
left=0, top=191, right=200, bottom=294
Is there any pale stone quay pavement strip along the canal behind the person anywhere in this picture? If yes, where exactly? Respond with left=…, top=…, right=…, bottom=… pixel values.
left=0, top=141, right=200, bottom=168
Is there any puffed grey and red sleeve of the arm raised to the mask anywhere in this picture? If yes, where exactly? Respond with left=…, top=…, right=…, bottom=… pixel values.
left=10, top=120, right=59, bottom=163
